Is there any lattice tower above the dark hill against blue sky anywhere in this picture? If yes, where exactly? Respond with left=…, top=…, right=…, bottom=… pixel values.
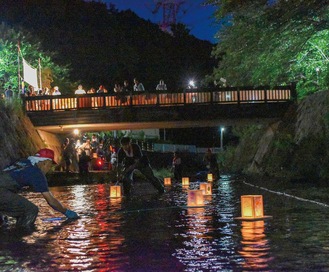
left=153, top=0, right=185, bottom=32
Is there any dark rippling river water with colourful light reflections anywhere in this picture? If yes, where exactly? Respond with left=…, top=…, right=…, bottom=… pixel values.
left=0, top=176, right=329, bottom=271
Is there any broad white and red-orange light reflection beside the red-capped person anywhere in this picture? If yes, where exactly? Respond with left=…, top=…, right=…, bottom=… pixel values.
left=49, top=184, right=128, bottom=271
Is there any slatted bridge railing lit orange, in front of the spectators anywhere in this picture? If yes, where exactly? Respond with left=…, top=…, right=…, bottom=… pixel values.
left=23, top=86, right=296, bottom=112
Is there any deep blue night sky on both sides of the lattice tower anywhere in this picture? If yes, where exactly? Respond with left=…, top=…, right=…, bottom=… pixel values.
left=103, top=0, right=218, bottom=43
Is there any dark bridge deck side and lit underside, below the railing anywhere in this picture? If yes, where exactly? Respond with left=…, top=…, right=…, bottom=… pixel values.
left=28, top=103, right=291, bottom=134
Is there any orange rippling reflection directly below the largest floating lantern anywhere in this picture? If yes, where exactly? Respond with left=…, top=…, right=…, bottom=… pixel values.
left=238, top=220, right=271, bottom=271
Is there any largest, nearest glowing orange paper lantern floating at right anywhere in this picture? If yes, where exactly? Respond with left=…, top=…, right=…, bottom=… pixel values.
left=237, top=195, right=271, bottom=220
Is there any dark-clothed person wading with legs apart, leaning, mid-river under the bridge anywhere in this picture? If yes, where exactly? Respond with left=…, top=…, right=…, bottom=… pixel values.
left=118, top=137, right=165, bottom=197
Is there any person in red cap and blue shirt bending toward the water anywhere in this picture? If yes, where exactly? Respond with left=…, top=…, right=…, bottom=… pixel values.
left=0, top=148, right=79, bottom=230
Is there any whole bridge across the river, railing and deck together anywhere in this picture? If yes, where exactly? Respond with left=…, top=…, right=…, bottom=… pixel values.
left=23, top=85, right=296, bottom=133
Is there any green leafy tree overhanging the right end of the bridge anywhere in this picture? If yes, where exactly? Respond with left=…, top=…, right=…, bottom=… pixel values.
left=207, top=0, right=329, bottom=96
